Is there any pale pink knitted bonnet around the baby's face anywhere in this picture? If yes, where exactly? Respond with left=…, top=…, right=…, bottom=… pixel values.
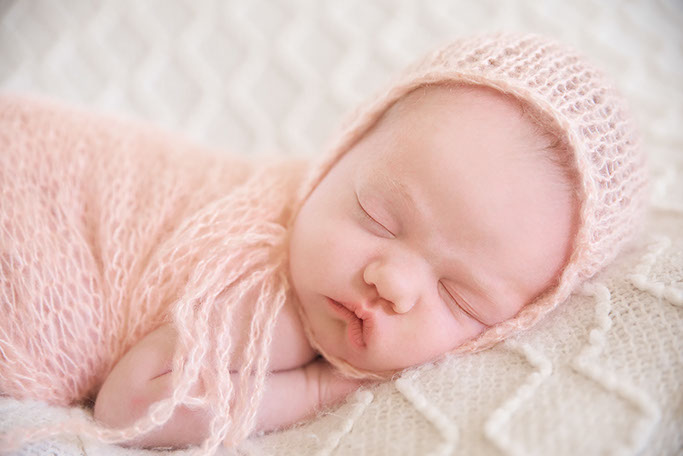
left=294, top=34, right=646, bottom=377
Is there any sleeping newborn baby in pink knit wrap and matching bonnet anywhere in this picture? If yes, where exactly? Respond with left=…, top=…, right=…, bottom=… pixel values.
left=0, top=35, right=645, bottom=453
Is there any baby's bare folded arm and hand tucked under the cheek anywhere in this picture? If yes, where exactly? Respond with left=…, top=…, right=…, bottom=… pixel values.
left=94, top=325, right=368, bottom=447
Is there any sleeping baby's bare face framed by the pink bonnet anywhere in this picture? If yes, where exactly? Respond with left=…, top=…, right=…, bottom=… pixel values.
left=290, top=87, right=574, bottom=371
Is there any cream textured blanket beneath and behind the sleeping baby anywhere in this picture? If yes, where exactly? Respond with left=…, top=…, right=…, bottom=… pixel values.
left=0, top=0, right=683, bottom=456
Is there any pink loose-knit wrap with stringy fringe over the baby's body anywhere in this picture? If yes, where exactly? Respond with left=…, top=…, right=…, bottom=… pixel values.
left=0, top=95, right=304, bottom=453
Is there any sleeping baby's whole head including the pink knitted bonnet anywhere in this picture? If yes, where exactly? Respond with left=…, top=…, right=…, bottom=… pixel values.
left=290, top=36, right=644, bottom=374
